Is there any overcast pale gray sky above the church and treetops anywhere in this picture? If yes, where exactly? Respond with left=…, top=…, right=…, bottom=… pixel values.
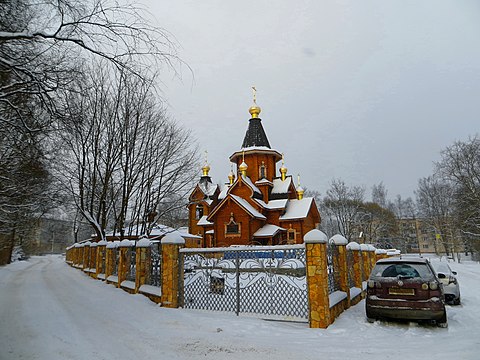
left=140, top=0, right=480, bottom=198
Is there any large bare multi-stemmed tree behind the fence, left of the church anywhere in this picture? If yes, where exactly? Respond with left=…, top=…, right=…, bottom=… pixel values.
left=56, top=67, right=196, bottom=242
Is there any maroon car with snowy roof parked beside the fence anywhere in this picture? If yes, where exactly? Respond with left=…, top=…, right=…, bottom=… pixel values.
left=365, top=257, right=447, bottom=327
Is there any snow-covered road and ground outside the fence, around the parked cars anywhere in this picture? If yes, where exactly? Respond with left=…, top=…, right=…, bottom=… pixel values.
left=0, top=256, right=480, bottom=360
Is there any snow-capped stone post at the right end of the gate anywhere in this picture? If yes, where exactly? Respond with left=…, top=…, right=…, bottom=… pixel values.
left=303, top=229, right=330, bottom=329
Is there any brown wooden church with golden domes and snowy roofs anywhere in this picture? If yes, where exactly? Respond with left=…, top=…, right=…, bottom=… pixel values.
left=188, top=89, right=320, bottom=247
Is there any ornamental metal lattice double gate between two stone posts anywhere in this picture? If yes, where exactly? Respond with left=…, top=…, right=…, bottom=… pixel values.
left=179, top=245, right=308, bottom=320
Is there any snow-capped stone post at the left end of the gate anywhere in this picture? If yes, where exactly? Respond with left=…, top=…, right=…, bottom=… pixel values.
left=161, top=232, right=185, bottom=308
